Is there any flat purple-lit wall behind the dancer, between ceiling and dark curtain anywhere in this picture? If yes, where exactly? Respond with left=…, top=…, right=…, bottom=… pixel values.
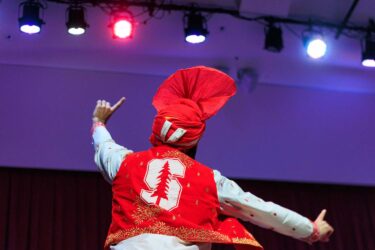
left=0, top=65, right=375, bottom=185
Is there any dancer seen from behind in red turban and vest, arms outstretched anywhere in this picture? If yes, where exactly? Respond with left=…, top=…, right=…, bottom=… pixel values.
left=92, top=66, right=333, bottom=250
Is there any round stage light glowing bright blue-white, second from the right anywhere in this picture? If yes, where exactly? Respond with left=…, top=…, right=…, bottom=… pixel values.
left=303, top=30, right=327, bottom=59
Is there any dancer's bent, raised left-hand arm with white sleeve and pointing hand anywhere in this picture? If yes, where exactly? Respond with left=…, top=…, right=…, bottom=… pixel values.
left=91, top=97, right=133, bottom=183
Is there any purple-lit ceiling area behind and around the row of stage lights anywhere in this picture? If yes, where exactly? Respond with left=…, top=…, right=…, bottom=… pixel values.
left=0, top=0, right=375, bottom=93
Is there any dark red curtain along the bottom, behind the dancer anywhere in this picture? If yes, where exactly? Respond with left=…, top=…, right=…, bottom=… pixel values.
left=0, top=168, right=375, bottom=250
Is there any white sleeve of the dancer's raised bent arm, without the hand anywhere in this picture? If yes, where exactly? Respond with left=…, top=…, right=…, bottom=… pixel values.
left=92, top=126, right=133, bottom=183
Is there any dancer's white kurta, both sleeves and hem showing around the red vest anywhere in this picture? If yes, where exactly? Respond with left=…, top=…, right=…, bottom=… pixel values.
left=93, top=126, right=313, bottom=250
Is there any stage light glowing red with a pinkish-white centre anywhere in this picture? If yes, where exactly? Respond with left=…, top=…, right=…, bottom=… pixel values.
left=110, top=12, right=134, bottom=39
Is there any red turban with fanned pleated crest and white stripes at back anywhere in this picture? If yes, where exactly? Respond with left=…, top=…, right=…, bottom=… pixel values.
left=150, top=66, right=236, bottom=149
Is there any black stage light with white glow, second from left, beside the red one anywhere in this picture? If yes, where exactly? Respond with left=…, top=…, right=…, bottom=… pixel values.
left=66, top=6, right=88, bottom=36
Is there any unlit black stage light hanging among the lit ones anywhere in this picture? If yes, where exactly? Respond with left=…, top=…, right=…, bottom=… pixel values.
left=264, top=23, right=284, bottom=52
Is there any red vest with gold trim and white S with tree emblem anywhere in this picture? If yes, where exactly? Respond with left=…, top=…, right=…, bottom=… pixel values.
left=105, top=146, right=262, bottom=249
